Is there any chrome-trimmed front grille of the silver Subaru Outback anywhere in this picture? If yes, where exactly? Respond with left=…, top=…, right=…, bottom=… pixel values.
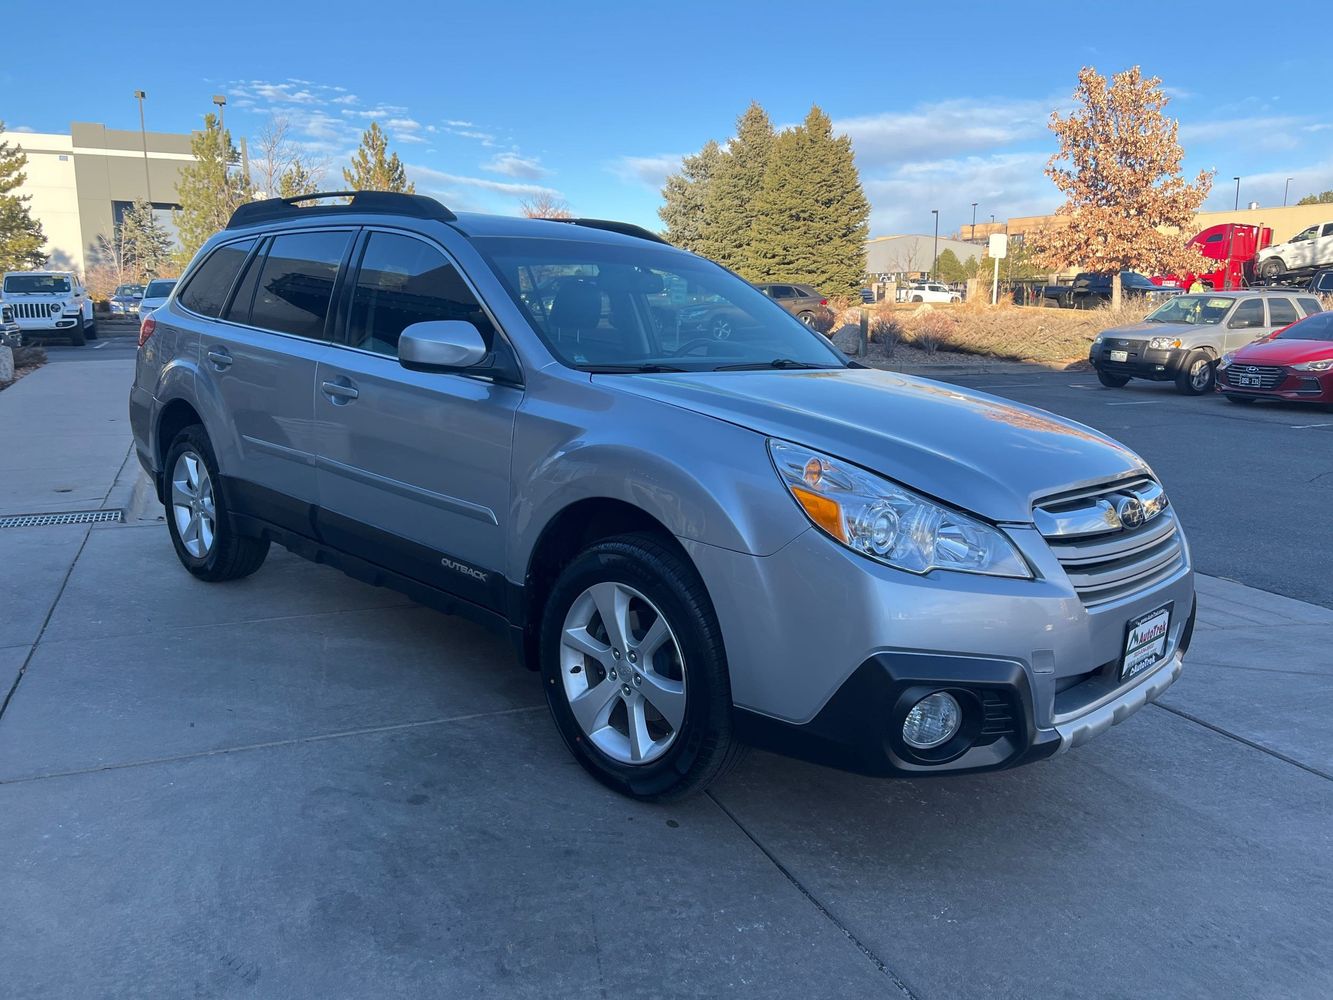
left=1033, top=476, right=1185, bottom=608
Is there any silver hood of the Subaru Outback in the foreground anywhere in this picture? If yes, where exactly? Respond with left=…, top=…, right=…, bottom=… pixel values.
left=605, top=368, right=1148, bottom=521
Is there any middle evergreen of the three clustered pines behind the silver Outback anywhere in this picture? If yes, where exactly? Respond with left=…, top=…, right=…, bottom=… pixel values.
left=696, top=103, right=773, bottom=271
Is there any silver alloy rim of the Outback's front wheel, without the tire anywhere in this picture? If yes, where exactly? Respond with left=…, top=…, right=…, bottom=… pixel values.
left=560, top=583, right=685, bottom=764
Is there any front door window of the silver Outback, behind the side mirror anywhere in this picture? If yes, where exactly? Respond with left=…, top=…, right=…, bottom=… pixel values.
left=347, top=232, right=495, bottom=357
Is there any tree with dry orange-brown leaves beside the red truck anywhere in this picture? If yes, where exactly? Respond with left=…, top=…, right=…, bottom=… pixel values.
left=1034, top=67, right=1213, bottom=307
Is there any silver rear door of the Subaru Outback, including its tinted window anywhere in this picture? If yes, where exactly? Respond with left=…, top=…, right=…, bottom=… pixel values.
left=194, top=228, right=355, bottom=536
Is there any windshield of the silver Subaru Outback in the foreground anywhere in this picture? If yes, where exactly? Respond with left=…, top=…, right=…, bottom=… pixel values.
left=475, top=237, right=846, bottom=372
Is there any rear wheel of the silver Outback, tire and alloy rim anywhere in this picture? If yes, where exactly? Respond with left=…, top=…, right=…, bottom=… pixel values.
left=163, top=424, right=268, bottom=583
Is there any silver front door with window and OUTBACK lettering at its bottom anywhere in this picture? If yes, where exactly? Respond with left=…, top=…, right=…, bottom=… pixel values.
left=315, top=229, right=523, bottom=609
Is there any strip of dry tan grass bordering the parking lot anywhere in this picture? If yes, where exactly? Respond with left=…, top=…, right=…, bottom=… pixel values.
left=837, top=303, right=1148, bottom=364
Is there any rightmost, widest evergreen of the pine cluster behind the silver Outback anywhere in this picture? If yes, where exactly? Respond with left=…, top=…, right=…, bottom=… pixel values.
left=740, top=107, right=870, bottom=295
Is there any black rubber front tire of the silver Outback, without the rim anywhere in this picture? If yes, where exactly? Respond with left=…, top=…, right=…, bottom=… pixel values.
left=539, top=533, right=745, bottom=801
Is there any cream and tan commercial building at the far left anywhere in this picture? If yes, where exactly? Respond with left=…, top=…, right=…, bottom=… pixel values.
left=0, top=121, right=195, bottom=275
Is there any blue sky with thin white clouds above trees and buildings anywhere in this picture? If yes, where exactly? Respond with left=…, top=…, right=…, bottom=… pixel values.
left=0, top=0, right=1333, bottom=235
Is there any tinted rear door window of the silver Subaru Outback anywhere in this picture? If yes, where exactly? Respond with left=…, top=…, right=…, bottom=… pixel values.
left=249, top=232, right=351, bottom=340
